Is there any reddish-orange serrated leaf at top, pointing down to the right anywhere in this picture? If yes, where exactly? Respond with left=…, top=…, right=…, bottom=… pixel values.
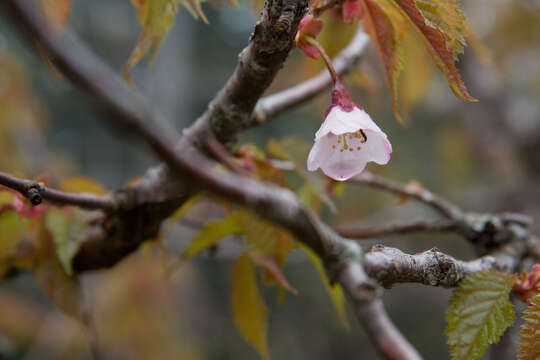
left=394, top=0, right=476, bottom=101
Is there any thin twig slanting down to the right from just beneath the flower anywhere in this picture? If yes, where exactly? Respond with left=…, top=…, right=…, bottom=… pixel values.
left=352, top=171, right=463, bottom=220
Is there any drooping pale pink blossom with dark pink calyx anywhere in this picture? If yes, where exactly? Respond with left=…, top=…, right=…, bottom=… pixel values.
left=307, top=81, right=392, bottom=181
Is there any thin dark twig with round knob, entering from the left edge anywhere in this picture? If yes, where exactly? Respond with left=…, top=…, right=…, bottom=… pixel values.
left=0, top=172, right=118, bottom=212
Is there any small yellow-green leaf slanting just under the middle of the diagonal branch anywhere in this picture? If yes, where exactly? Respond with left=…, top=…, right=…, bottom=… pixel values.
left=182, top=213, right=243, bottom=260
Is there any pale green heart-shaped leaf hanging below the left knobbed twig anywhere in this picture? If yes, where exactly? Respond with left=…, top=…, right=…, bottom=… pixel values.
left=45, top=208, right=88, bottom=275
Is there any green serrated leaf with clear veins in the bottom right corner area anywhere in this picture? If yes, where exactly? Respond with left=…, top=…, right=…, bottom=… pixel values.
left=446, top=270, right=516, bottom=360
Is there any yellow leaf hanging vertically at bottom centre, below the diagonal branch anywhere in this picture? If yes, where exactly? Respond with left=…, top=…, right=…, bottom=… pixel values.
left=231, top=254, right=270, bottom=360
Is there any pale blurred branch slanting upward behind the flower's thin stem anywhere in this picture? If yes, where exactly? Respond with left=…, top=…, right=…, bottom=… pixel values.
left=252, top=27, right=369, bottom=124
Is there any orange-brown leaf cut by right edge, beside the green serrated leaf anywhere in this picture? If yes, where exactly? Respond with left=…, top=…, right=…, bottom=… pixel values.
left=519, top=295, right=540, bottom=360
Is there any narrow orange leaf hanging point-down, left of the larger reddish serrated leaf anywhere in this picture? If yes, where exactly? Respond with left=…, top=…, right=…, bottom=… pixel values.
left=364, top=0, right=408, bottom=122
